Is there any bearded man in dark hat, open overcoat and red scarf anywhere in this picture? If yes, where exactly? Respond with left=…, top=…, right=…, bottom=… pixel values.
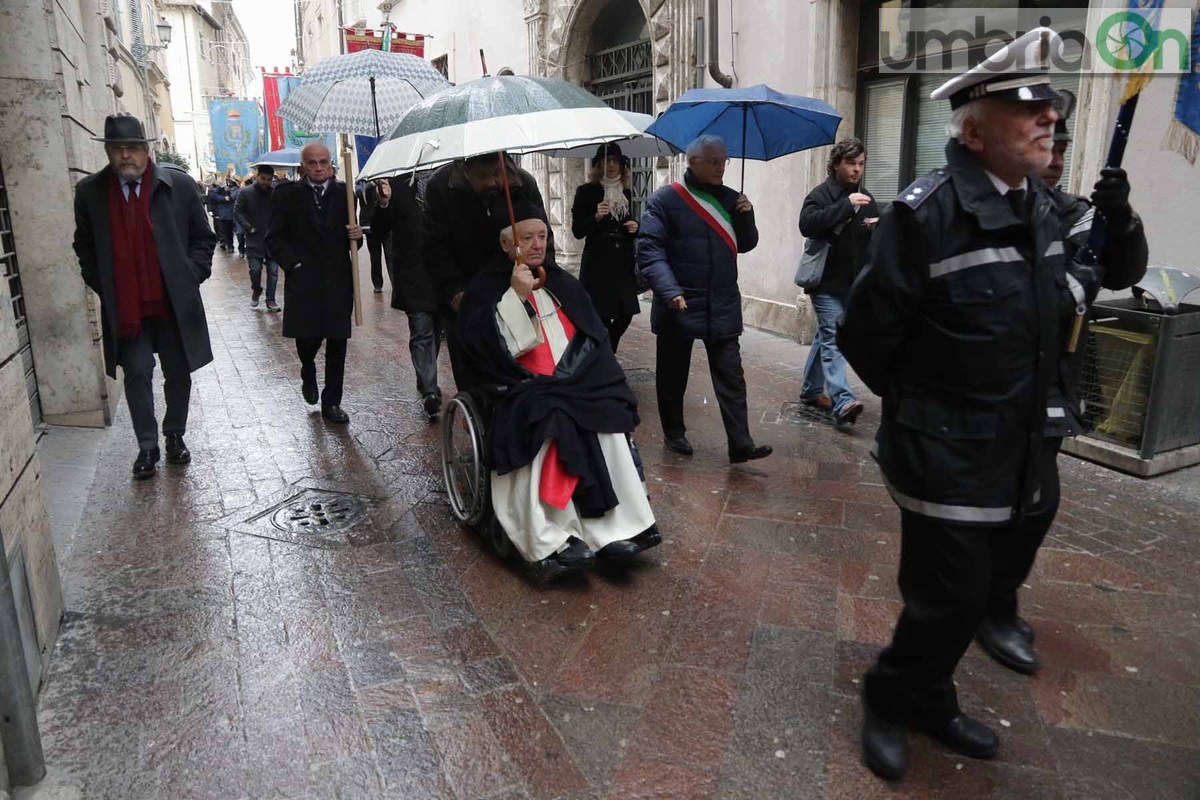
left=74, top=114, right=216, bottom=480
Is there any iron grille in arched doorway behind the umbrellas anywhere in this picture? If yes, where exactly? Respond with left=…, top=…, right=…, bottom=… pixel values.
left=588, top=40, right=654, bottom=219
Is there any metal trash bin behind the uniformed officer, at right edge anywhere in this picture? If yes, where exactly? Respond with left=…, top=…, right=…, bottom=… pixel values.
left=1064, top=267, right=1200, bottom=476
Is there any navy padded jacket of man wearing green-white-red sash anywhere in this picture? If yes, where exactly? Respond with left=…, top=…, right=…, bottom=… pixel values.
left=637, top=169, right=758, bottom=341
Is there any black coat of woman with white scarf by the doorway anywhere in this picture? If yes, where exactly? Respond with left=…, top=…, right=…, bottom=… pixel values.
left=571, top=184, right=641, bottom=319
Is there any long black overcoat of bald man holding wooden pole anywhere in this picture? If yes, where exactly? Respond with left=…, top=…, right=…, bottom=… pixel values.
left=266, top=181, right=354, bottom=339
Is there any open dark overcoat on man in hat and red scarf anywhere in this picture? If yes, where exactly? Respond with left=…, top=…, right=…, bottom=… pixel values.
left=74, top=166, right=217, bottom=378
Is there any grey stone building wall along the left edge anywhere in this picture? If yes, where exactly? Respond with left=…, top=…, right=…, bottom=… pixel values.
left=0, top=0, right=145, bottom=738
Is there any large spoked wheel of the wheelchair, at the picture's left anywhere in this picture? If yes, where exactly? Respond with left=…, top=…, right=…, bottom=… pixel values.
left=442, top=395, right=487, bottom=535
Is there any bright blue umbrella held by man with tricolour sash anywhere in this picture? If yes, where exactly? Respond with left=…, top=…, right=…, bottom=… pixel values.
left=646, top=84, right=841, bottom=186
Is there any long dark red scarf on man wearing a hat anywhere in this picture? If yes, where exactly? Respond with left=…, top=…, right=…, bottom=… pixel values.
left=108, top=161, right=168, bottom=338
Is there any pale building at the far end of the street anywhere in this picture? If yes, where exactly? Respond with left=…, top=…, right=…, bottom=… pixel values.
left=162, top=0, right=254, bottom=180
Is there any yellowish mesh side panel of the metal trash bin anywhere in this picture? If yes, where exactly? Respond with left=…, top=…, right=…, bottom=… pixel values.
left=1080, top=320, right=1158, bottom=449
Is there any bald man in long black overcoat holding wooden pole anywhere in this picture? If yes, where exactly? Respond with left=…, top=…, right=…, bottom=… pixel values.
left=266, top=143, right=362, bottom=425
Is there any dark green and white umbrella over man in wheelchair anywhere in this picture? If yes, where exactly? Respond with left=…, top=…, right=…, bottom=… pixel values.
left=362, top=76, right=641, bottom=179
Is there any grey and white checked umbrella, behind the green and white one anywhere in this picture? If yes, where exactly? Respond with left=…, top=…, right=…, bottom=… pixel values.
left=280, top=50, right=450, bottom=137
